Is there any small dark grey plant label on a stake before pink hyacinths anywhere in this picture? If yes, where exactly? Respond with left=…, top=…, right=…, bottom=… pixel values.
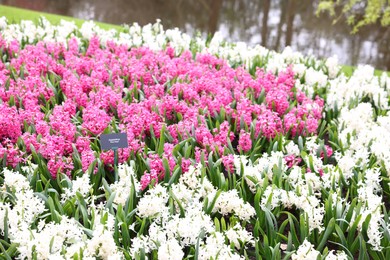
left=100, top=133, right=129, bottom=181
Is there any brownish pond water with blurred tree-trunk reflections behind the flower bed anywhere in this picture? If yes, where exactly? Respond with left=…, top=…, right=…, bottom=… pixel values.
left=0, top=0, right=390, bottom=70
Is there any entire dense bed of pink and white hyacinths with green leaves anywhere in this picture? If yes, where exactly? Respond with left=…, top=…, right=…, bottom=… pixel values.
left=0, top=18, right=390, bottom=259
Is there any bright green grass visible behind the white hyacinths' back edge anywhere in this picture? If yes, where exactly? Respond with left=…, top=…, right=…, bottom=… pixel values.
left=0, top=5, right=390, bottom=77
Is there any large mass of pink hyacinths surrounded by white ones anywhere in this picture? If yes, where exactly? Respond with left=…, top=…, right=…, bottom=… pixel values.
left=0, top=36, right=323, bottom=180
